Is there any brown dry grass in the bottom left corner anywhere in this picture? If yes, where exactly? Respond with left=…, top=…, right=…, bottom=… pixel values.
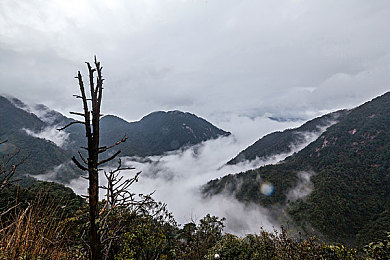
left=0, top=195, right=78, bottom=259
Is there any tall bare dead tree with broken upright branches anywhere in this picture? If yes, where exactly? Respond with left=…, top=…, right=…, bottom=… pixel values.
left=58, top=56, right=127, bottom=260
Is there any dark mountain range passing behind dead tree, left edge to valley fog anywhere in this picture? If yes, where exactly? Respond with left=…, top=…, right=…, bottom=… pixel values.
left=0, top=96, right=230, bottom=182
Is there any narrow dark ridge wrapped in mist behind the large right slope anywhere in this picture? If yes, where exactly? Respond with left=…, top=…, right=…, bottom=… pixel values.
left=227, top=110, right=348, bottom=164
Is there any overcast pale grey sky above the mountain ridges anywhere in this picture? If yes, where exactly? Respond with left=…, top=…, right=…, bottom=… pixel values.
left=0, top=0, right=390, bottom=121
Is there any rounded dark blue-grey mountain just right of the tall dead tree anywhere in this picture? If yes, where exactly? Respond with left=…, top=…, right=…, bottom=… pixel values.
left=101, top=111, right=230, bottom=156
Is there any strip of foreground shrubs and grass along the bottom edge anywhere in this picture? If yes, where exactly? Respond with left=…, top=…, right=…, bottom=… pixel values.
left=0, top=182, right=390, bottom=260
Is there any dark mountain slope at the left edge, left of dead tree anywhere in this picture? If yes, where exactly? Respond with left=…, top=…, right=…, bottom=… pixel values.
left=0, top=96, right=77, bottom=181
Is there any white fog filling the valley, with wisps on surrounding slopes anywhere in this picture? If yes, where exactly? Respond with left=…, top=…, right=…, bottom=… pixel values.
left=32, top=117, right=330, bottom=235
